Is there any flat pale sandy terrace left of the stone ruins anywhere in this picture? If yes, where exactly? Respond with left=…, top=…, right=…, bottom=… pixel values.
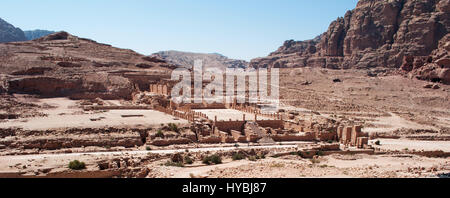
left=0, top=98, right=188, bottom=130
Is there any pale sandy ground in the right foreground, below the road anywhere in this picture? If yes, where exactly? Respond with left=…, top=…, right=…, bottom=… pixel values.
left=154, top=155, right=450, bottom=178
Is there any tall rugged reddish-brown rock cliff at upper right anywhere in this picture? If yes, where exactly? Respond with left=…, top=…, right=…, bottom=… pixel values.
left=250, top=0, right=450, bottom=81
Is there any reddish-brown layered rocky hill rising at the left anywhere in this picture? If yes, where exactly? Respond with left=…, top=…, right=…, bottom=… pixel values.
left=0, top=32, right=174, bottom=99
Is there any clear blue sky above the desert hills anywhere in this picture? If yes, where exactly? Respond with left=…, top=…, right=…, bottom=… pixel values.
left=0, top=0, right=357, bottom=60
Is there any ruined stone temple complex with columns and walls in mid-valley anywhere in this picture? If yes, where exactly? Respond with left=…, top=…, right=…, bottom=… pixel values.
left=142, top=75, right=369, bottom=149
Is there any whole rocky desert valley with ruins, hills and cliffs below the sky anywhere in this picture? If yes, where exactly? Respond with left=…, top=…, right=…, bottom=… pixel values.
left=0, top=0, right=450, bottom=178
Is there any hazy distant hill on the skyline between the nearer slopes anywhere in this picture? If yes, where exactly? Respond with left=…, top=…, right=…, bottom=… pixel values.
left=153, top=51, right=248, bottom=68
